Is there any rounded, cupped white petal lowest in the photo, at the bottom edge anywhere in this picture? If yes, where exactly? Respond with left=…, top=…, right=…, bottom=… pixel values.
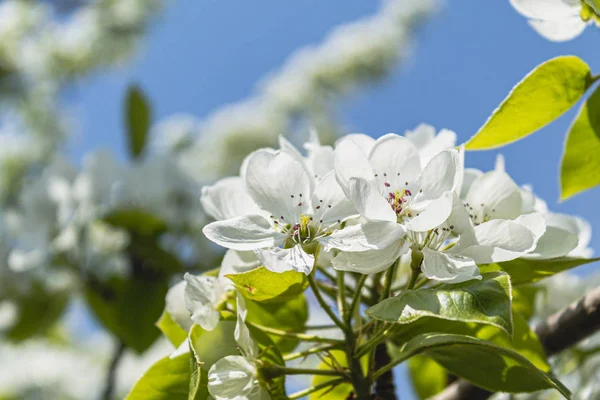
left=208, top=356, right=256, bottom=400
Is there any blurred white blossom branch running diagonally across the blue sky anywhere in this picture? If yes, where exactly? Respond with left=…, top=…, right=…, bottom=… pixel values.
left=181, top=0, right=438, bottom=180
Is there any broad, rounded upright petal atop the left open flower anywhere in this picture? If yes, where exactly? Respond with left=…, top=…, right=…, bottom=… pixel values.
left=246, top=150, right=311, bottom=224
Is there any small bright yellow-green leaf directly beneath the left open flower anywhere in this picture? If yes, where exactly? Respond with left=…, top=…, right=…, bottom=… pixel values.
left=227, top=267, right=308, bottom=302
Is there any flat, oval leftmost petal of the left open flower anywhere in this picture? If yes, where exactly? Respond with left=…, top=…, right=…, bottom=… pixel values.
left=202, top=215, right=287, bottom=250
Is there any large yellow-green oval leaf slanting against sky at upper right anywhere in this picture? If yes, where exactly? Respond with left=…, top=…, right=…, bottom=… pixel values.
left=465, top=56, right=593, bottom=150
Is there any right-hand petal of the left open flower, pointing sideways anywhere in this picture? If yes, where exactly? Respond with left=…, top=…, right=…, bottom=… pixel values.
left=319, top=221, right=406, bottom=252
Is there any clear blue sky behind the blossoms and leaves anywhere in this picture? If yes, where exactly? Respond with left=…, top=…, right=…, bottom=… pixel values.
left=68, top=0, right=600, bottom=399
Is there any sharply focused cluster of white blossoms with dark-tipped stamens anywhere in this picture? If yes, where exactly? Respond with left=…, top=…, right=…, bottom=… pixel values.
left=202, top=125, right=589, bottom=283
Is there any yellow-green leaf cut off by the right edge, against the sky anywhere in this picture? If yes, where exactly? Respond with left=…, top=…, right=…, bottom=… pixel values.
left=560, top=84, right=600, bottom=200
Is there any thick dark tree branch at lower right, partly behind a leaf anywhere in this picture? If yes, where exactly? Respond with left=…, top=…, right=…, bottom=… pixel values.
left=432, top=287, right=600, bottom=400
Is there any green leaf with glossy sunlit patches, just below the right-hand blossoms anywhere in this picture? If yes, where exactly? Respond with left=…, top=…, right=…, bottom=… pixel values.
left=366, top=273, right=512, bottom=334
